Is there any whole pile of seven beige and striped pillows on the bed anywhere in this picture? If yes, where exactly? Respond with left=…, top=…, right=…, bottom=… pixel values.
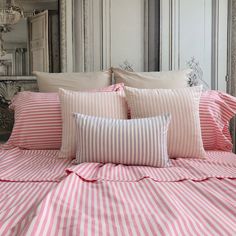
left=8, top=68, right=236, bottom=167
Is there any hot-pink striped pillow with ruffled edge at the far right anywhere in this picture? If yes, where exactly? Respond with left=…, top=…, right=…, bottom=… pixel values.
left=199, top=91, right=236, bottom=151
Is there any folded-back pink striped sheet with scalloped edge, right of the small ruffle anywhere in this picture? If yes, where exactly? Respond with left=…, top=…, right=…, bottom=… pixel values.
left=67, top=151, right=236, bottom=182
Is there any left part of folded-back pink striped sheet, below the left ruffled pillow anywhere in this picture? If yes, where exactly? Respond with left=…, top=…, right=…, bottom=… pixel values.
left=0, top=148, right=70, bottom=182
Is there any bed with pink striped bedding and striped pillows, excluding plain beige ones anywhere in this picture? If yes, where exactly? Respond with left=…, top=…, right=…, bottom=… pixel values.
left=0, top=70, right=236, bottom=236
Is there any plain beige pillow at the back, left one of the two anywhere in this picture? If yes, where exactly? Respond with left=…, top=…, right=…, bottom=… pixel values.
left=33, top=70, right=112, bottom=92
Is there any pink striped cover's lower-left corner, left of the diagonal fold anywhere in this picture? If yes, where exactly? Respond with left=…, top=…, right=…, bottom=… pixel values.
left=0, top=181, right=58, bottom=236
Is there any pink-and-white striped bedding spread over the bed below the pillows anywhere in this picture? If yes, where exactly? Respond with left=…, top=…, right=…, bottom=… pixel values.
left=0, top=149, right=236, bottom=235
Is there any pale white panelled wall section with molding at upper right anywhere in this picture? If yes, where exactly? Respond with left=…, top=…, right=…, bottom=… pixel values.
left=161, top=0, right=227, bottom=91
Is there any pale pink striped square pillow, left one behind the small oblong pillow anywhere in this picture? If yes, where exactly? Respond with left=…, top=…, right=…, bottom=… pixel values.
left=59, top=89, right=128, bottom=158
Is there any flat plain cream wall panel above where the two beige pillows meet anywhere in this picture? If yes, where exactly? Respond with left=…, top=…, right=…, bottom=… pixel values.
left=111, top=0, right=144, bottom=71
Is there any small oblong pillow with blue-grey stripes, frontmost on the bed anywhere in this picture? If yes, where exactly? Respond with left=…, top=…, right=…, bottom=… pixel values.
left=75, top=114, right=170, bottom=167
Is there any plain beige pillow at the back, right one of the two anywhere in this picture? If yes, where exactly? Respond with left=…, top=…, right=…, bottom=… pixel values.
left=112, top=68, right=191, bottom=89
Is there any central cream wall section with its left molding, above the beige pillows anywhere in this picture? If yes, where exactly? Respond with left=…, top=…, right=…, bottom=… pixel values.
left=72, top=0, right=147, bottom=71
